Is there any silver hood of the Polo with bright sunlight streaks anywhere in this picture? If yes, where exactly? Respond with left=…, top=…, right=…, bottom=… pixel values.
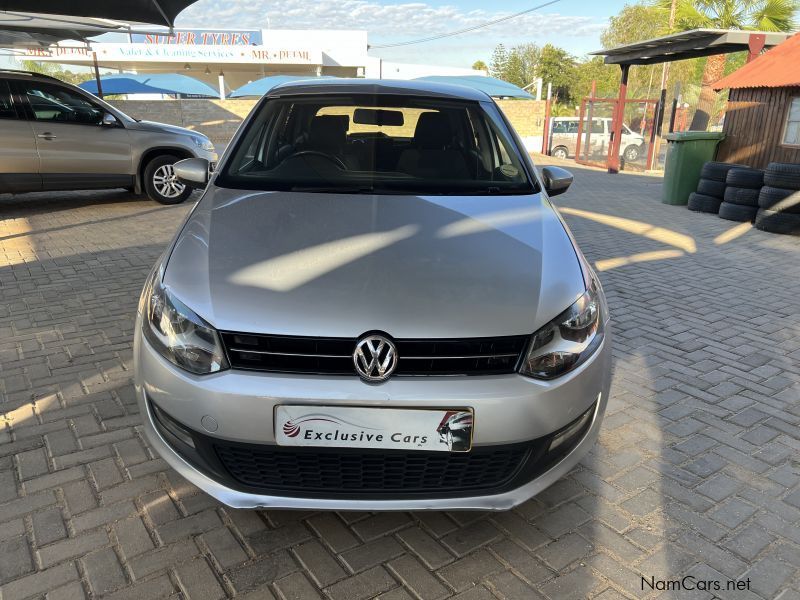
left=164, top=184, right=584, bottom=338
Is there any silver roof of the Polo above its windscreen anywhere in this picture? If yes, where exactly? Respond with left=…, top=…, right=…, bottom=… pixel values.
left=266, top=77, right=491, bottom=102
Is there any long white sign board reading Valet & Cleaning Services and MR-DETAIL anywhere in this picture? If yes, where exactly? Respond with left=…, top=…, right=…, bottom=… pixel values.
left=25, top=43, right=322, bottom=65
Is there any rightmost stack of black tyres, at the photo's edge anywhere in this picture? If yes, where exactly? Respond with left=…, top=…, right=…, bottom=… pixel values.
left=756, top=163, right=800, bottom=235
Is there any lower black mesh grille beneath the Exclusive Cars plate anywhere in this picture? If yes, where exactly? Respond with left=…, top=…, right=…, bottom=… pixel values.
left=214, top=443, right=531, bottom=493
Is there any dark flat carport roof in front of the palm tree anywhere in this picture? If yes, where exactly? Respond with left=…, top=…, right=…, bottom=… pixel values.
left=590, top=29, right=792, bottom=65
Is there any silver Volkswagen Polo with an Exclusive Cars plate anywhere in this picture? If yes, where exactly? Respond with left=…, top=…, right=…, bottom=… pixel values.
left=134, top=79, right=611, bottom=510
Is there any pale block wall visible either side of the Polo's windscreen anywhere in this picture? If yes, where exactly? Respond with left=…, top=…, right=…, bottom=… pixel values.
left=111, top=98, right=545, bottom=150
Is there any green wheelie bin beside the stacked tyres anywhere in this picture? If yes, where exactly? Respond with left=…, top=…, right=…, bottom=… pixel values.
left=661, top=131, right=725, bottom=205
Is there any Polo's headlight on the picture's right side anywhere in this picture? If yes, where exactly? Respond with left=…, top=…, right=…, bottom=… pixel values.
left=520, top=276, right=604, bottom=379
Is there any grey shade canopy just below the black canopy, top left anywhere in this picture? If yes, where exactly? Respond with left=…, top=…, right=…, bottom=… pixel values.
left=0, top=11, right=129, bottom=48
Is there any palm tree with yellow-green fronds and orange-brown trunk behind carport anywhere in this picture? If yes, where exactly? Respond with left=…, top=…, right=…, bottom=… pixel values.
left=656, top=0, right=800, bottom=131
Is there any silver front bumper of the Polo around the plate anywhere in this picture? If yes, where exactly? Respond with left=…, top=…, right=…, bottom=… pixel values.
left=134, top=323, right=611, bottom=511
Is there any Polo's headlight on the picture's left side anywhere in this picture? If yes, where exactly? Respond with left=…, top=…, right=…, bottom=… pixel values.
left=140, top=270, right=228, bottom=375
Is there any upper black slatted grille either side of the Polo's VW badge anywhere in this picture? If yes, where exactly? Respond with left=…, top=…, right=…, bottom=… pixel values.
left=221, top=332, right=529, bottom=376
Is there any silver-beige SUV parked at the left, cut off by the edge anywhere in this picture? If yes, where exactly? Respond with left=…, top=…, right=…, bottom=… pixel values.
left=0, top=70, right=217, bottom=204
